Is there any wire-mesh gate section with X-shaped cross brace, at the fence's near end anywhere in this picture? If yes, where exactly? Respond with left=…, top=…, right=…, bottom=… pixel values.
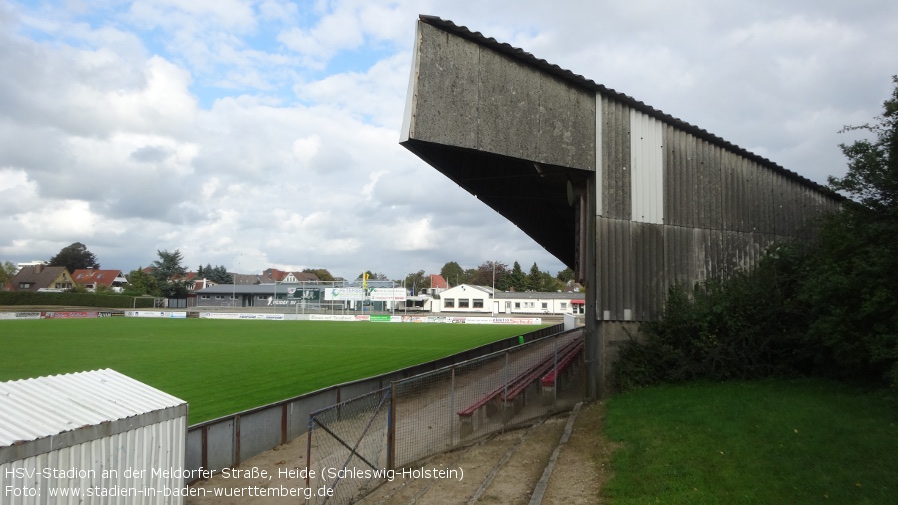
left=306, top=387, right=392, bottom=505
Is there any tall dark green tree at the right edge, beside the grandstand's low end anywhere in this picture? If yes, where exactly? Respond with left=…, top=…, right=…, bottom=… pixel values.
left=801, top=77, right=898, bottom=389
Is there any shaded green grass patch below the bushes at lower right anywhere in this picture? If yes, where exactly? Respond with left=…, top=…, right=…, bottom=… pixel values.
left=601, top=380, right=898, bottom=505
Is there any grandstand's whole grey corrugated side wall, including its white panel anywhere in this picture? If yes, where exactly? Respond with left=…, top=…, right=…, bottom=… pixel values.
left=596, top=90, right=837, bottom=321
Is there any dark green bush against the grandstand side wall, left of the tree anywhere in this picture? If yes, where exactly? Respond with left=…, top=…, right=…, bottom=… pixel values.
left=615, top=246, right=809, bottom=390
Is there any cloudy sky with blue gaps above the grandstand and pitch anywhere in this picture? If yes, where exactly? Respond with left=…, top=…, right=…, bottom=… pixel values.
left=0, top=0, right=898, bottom=278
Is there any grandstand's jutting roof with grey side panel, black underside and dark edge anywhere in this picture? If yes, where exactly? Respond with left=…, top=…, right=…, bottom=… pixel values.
left=400, top=16, right=841, bottom=267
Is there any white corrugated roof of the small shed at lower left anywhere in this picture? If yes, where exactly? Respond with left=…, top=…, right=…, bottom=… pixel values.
left=0, top=368, right=186, bottom=447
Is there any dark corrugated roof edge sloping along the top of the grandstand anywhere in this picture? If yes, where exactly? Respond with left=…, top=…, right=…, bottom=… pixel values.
left=419, top=15, right=845, bottom=200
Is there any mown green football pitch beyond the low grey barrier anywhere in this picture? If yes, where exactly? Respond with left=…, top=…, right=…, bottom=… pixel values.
left=0, top=318, right=542, bottom=424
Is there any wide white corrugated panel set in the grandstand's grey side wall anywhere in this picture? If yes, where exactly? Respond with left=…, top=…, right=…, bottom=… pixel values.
left=630, top=109, right=664, bottom=224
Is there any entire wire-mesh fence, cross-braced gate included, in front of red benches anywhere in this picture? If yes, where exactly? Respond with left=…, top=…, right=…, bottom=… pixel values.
left=306, top=328, right=585, bottom=504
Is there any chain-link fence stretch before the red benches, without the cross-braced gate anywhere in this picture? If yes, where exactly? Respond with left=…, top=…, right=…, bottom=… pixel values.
left=392, top=330, right=583, bottom=468
